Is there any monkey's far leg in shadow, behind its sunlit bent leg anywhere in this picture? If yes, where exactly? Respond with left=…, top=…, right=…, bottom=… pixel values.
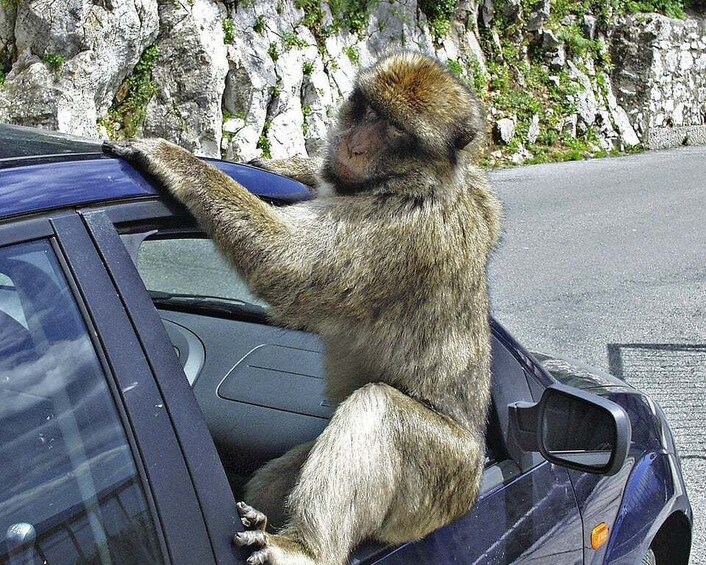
left=244, top=442, right=313, bottom=530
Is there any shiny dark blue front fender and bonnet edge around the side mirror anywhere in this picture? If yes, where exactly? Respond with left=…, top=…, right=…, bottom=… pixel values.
left=534, top=353, right=693, bottom=565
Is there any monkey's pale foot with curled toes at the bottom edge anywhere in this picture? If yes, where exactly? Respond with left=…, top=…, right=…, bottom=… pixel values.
left=233, top=502, right=316, bottom=565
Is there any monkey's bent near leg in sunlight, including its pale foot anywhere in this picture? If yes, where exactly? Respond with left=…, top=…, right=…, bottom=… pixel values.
left=235, top=384, right=484, bottom=565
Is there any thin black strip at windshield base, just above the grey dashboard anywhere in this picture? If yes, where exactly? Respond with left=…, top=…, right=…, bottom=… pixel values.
left=147, top=290, right=267, bottom=322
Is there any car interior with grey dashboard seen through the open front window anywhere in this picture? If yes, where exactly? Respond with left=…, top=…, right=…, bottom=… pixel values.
left=121, top=226, right=527, bottom=498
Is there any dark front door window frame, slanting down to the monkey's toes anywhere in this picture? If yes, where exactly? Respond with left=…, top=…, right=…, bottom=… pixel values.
left=80, top=204, right=242, bottom=564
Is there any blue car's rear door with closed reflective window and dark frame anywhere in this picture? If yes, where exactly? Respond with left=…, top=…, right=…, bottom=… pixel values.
left=0, top=213, right=223, bottom=565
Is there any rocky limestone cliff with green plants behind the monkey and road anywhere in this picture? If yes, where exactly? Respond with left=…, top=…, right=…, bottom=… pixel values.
left=0, top=0, right=706, bottom=163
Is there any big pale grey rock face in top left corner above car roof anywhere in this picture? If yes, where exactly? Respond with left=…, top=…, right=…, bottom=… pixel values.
left=0, top=0, right=159, bottom=136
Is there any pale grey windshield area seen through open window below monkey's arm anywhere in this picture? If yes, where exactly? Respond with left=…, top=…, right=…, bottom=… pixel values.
left=137, top=237, right=266, bottom=306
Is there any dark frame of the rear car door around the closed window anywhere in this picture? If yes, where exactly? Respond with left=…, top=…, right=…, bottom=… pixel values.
left=0, top=210, right=216, bottom=563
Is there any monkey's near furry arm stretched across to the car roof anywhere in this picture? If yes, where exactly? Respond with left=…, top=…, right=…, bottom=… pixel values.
left=106, top=139, right=322, bottom=306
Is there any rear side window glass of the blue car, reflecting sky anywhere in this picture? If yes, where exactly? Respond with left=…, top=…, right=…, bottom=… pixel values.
left=0, top=242, right=162, bottom=564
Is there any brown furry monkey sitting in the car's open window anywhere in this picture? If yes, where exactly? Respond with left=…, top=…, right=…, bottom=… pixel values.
left=108, top=51, right=501, bottom=565
